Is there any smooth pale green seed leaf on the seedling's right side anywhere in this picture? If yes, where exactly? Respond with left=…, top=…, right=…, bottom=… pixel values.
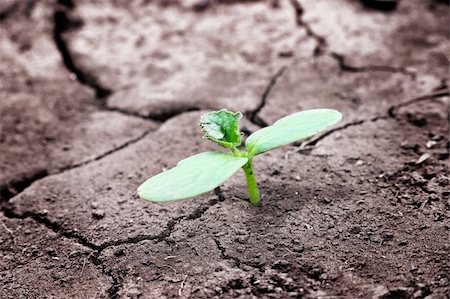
left=245, top=109, right=342, bottom=155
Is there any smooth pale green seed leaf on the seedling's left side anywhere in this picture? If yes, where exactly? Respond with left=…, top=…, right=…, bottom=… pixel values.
left=137, top=152, right=247, bottom=202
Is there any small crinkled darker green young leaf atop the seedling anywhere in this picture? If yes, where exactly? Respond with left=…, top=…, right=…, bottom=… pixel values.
left=199, top=109, right=242, bottom=148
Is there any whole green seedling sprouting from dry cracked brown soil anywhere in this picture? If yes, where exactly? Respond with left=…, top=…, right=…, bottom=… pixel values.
left=138, top=109, right=342, bottom=205
